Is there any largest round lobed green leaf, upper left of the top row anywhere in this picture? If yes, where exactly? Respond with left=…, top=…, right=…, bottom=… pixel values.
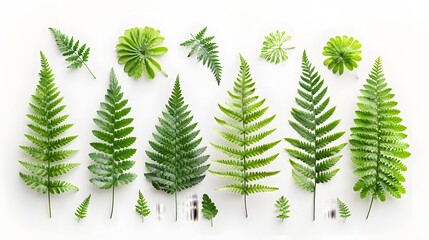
left=116, top=27, right=168, bottom=79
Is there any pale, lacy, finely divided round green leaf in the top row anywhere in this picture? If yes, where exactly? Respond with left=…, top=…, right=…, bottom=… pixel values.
left=260, top=30, right=294, bottom=64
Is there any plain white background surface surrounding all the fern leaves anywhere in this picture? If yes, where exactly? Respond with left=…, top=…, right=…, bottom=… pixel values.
left=0, top=0, right=429, bottom=239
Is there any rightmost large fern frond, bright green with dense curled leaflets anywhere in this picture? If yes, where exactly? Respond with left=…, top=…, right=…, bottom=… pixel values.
left=350, top=58, right=411, bottom=218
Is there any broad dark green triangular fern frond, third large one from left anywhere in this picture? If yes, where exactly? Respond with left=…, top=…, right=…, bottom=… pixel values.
left=145, top=76, right=210, bottom=221
